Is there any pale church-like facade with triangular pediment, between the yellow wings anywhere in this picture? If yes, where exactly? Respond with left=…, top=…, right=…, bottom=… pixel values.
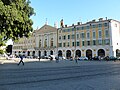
left=35, top=24, right=57, bottom=56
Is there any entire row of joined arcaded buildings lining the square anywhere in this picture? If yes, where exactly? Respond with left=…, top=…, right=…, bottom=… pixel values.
left=13, top=18, right=120, bottom=58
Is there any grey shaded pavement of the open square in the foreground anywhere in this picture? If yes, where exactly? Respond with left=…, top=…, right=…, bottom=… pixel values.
left=0, top=61, right=120, bottom=90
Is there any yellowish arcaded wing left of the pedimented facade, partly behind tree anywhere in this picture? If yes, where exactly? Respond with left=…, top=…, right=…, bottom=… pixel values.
left=13, top=31, right=36, bottom=56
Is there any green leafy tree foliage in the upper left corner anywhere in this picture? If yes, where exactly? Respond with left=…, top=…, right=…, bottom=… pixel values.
left=0, top=0, right=34, bottom=46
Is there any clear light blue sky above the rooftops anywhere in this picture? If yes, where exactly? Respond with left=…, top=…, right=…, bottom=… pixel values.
left=30, top=0, right=120, bottom=29
